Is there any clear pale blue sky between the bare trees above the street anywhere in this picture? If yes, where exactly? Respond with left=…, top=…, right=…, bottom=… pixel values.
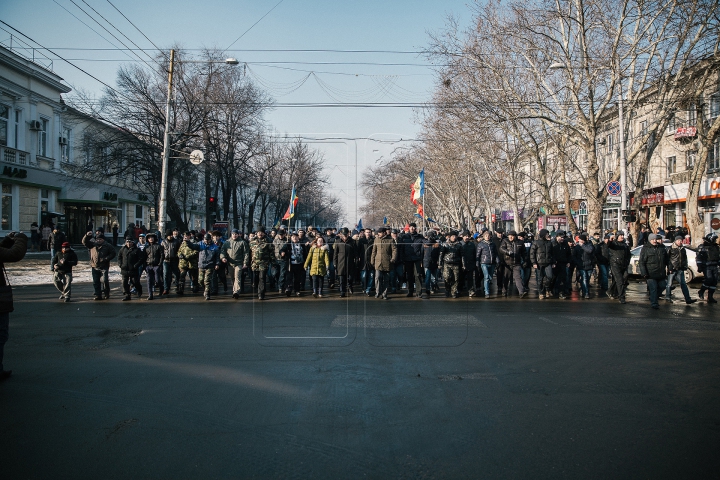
left=0, top=0, right=471, bottom=227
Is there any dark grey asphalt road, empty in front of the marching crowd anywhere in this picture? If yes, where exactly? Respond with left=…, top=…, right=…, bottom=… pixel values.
left=0, top=285, right=720, bottom=479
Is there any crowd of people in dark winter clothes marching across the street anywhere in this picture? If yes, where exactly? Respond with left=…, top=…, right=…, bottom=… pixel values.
left=46, top=223, right=719, bottom=308
